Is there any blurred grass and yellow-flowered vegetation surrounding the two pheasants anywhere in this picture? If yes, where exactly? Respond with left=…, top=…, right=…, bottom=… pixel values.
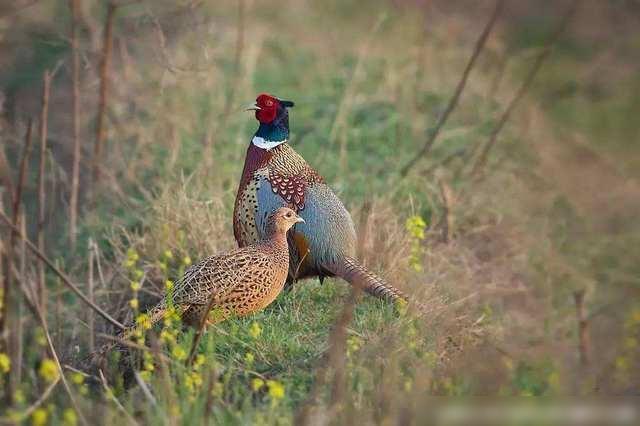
left=0, top=0, right=640, bottom=425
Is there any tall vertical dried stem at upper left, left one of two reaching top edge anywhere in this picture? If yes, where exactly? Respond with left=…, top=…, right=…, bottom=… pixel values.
left=69, top=0, right=80, bottom=251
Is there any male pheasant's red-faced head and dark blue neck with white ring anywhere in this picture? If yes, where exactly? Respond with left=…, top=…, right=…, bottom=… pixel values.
left=247, top=93, right=294, bottom=151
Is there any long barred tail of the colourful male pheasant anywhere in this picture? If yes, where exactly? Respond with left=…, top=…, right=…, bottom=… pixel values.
left=323, top=257, right=407, bottom=302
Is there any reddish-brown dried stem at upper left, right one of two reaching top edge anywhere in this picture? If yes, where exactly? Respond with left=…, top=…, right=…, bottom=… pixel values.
left=93, top=2, right=118, bottom=185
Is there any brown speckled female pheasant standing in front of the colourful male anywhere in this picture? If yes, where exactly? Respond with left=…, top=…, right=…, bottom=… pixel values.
left=92, top=207, right=304, bottom=363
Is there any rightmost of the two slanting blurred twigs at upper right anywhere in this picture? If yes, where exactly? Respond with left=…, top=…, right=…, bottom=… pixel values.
left=471, top=0, right=581, bottom=176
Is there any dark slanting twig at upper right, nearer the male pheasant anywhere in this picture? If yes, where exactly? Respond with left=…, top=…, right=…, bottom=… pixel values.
left=400, top=0, right=504, bottom=177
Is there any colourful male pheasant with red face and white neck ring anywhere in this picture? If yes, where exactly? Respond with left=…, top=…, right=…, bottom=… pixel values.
left=233, top=94, right=404, bottom=300
